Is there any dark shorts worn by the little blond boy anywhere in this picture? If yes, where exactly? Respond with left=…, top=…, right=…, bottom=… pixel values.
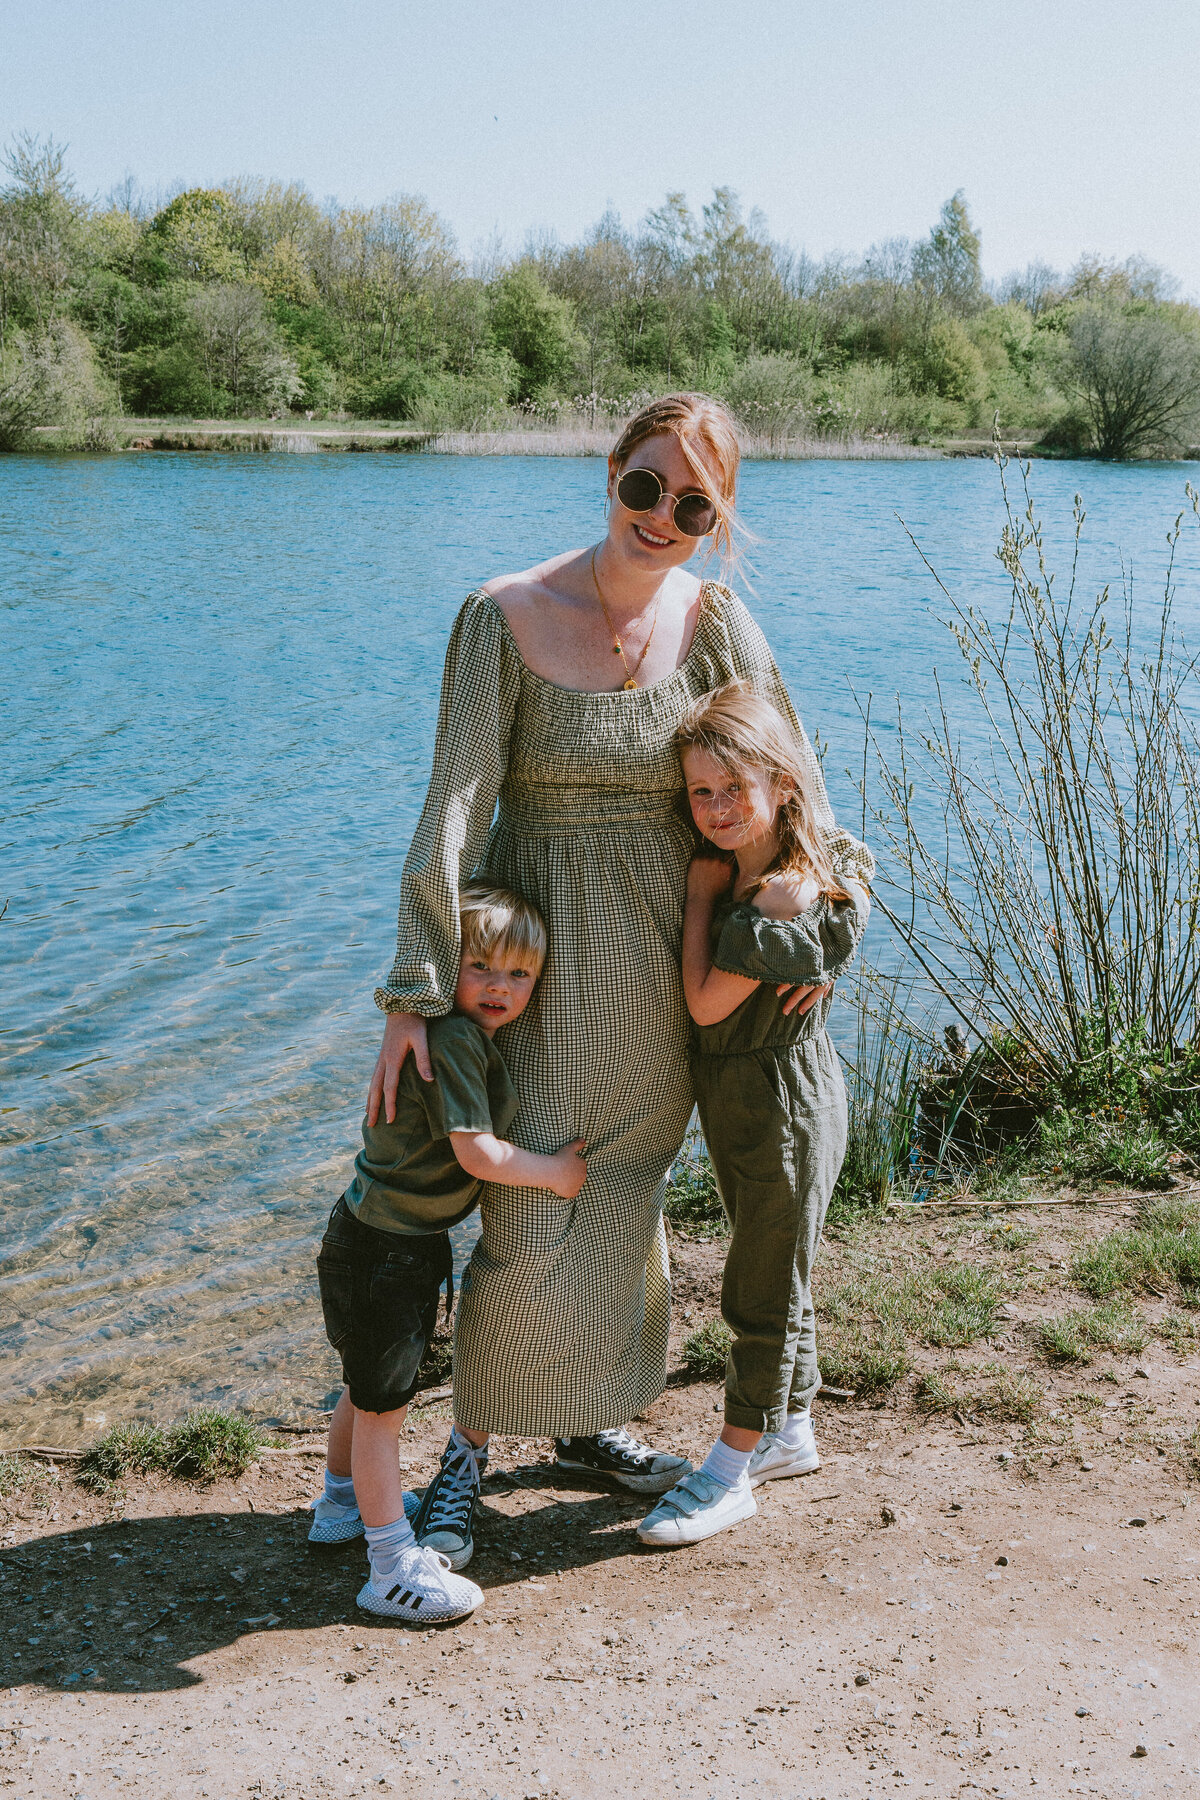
left=317, top=1197, right=453, bottom=1413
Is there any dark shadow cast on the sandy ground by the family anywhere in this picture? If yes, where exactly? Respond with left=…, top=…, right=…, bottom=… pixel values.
left=0, top=1465, right=665, bottom=1692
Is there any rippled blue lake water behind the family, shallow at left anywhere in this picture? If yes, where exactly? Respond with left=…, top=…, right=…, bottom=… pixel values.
left=0, top=455, right=1200, bottom=1442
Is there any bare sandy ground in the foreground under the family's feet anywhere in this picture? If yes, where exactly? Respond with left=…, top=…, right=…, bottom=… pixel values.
left=0, top=1219, right=1200, bottom=1800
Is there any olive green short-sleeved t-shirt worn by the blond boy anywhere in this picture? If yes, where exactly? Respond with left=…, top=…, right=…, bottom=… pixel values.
left=345, top=1013, right=516, bottom=1235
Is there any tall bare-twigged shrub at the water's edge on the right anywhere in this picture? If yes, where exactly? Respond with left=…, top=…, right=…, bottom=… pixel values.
left=867, top=463, right=1200, bottom=1103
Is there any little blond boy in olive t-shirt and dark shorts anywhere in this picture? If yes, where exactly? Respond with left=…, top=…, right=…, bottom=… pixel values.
left=308, top=882, right=587, bottom=1622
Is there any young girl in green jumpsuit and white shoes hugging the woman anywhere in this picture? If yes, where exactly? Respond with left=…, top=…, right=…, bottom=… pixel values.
left=639, top=682, right=869, bottom=1546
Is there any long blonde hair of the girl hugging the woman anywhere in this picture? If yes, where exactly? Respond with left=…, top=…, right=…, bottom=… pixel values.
left=675, top=680, right=849, bottom=900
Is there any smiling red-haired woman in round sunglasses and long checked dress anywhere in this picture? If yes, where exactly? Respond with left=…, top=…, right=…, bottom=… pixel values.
left=367, top=394, right=871, bottom=1568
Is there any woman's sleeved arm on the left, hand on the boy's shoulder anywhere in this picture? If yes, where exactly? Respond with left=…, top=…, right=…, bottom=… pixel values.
left=367, top=594, right=520, bottom=1125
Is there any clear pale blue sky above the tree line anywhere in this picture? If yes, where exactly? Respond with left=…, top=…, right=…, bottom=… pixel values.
left=9, top=0, right=1200, bottom=295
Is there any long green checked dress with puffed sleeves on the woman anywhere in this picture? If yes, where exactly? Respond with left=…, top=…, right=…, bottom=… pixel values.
left=376, top=581, right=873, bottom=1436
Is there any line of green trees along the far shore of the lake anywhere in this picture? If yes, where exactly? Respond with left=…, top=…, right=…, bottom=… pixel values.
left=0, top=135, right=1200, bottom=457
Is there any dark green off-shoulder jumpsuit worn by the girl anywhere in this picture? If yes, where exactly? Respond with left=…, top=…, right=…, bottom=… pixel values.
left=691, top=884, right=869, bottom=1433
